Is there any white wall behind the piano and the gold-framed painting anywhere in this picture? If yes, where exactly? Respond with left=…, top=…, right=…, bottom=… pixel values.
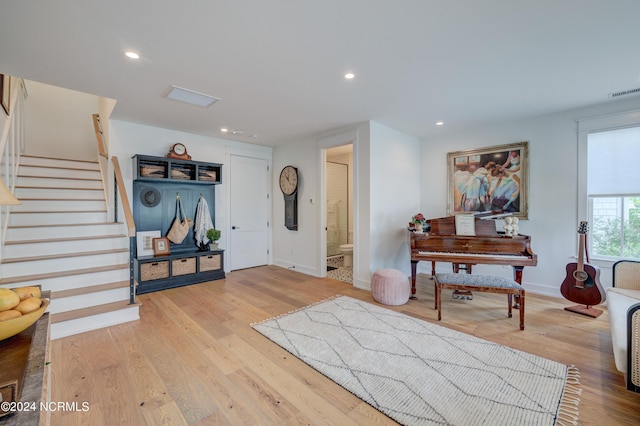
left=421, top=97, right=640, bottom=297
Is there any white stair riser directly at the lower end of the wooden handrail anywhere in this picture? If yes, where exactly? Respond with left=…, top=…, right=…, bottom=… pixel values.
left=4, top=237, right=129, bottom=259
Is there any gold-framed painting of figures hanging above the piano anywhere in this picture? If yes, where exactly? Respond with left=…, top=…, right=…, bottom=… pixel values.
left=447, top=142, right=529, bottom=219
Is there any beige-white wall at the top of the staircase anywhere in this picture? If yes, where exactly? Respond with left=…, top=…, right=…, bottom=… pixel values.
left=24, top=81, right=99, bottom=160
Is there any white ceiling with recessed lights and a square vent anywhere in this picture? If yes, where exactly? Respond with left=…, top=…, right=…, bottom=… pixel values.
left=0, top=0, right=640, bottom=146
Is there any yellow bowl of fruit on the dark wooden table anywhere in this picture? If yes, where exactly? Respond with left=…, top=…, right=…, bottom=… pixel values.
left=0, top=287, right=49, bottom=340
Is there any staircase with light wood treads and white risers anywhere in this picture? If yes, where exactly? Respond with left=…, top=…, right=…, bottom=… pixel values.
left=0, top=155, right=139, bottom=339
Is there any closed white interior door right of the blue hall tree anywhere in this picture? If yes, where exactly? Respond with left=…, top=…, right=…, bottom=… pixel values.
left=229, top=155, right=269, bottom=271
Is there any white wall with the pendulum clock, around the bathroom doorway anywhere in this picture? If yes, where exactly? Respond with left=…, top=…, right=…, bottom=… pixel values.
left=273, top=122, right=421, bottom=289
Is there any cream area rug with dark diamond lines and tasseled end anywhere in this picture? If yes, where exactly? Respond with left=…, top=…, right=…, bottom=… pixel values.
left=252, top=296, right=581, bottom=426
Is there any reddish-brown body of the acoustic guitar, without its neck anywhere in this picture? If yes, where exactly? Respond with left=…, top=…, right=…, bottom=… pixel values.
left=560, top=263, right=606, bottom=306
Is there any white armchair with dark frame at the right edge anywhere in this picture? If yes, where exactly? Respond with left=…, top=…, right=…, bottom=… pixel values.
left=607, top=260, right=640, bottom=392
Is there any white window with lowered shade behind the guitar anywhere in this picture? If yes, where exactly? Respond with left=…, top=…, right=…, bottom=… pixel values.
left=586, top=121, right=640, bottom=259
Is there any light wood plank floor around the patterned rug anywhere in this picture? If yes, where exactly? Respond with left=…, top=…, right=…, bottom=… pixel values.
left=51, top=266, right=640, bottom=426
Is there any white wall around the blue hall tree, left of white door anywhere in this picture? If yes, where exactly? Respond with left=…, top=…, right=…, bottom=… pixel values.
left=103, top=120, right=273, bottom=271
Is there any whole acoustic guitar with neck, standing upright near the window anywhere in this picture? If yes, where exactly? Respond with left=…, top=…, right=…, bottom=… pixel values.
left=560, top=221, right=606, bottom=318
